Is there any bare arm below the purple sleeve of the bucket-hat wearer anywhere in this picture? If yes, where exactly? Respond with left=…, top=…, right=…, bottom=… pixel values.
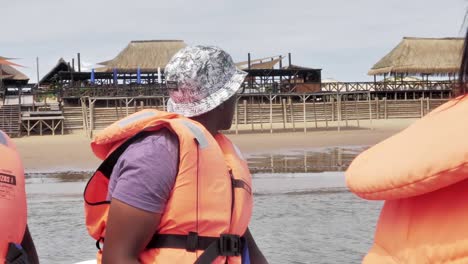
left=102, top=198, right=161, bottom=264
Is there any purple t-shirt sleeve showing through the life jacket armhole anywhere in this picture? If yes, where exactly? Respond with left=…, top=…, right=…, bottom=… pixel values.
left=107, top=129, right=179, bottom=213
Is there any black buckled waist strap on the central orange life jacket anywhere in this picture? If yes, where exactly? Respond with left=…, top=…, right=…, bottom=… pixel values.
left=146, top=232, right=245, bottom=264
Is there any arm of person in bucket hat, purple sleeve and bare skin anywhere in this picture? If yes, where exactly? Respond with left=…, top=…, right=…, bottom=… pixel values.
left=103, top=130, right=179, bottom=264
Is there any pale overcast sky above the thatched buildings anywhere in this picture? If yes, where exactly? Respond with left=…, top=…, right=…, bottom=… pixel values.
left=0, top=0, right=468, bottom=82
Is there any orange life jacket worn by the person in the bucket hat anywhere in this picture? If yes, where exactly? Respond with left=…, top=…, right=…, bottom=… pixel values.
left=84, top=110, right=253, bottom=263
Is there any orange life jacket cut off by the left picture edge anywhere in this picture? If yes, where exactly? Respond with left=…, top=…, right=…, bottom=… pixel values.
left=0, top=131, right=27, bottom=263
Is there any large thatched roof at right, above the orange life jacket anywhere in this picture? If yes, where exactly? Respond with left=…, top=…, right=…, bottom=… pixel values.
left=368, top=37, right=464, bottom=75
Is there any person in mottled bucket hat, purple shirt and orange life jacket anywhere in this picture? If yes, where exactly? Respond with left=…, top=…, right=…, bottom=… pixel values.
left=84, top=46, right=267, bottom=264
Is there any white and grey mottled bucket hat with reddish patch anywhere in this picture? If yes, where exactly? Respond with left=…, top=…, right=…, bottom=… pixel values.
left=164, top=46, right=247, bottom=117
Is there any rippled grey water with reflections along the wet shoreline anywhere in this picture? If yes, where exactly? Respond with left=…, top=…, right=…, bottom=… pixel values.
left=26, top=147, right=382, bottom=264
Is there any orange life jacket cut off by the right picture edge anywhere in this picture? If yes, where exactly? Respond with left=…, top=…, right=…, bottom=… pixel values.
left=346, top=96, right=468, bottom=263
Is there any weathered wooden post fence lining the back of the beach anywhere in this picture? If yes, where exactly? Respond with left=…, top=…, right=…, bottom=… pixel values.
left=63, top=92, right=449, bottom=136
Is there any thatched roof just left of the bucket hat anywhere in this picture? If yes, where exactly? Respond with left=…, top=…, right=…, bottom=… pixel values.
left=98, top=40, right=187, bottom=72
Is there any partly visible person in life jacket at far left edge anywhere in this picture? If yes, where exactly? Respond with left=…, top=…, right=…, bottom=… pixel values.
left=0, top=130, right=39, bottom=264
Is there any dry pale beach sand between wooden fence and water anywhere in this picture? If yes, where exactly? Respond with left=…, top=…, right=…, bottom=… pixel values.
left=14, top=119, right=417, bottom=172
